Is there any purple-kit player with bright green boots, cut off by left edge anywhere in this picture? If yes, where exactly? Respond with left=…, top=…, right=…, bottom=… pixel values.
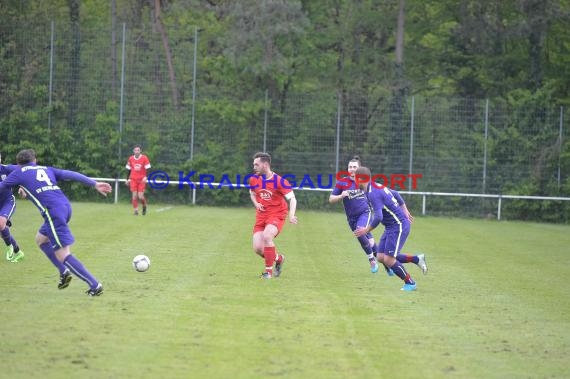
left=0, top=154, right=24, bottom=263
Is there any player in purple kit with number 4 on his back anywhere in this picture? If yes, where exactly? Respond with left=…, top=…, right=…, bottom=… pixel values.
left=0, top=149, right=112, bottom=296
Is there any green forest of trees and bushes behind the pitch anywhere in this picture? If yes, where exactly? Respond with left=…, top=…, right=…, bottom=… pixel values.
left=0, top=0, right=570, bottom=222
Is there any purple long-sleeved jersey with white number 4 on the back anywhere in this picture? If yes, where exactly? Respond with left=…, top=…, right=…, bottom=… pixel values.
left=0, top=164, right=96, bottom=212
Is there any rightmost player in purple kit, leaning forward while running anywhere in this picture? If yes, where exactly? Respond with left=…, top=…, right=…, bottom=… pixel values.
left=354, top=167, right=416, bottom=291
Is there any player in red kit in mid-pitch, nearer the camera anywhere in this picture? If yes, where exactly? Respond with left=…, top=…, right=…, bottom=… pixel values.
left=249, top=153, right=297, bottom=279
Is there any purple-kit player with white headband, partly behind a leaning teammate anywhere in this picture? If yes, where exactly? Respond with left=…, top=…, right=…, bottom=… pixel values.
left=329, top=156, right=378, bottom=273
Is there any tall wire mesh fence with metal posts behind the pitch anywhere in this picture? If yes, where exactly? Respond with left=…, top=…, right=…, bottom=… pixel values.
left=0, top=23, right=570, bottom=220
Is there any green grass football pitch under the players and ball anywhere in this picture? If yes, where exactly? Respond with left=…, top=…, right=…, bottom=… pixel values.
left=0, top=201, right=570, bottom=379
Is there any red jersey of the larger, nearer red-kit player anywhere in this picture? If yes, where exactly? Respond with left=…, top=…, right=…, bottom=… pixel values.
left=249, top=173, right=293, bottom=215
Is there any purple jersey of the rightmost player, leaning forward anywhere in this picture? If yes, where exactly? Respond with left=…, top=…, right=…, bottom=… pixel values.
left=367, top=185, right=410, bottom=228
